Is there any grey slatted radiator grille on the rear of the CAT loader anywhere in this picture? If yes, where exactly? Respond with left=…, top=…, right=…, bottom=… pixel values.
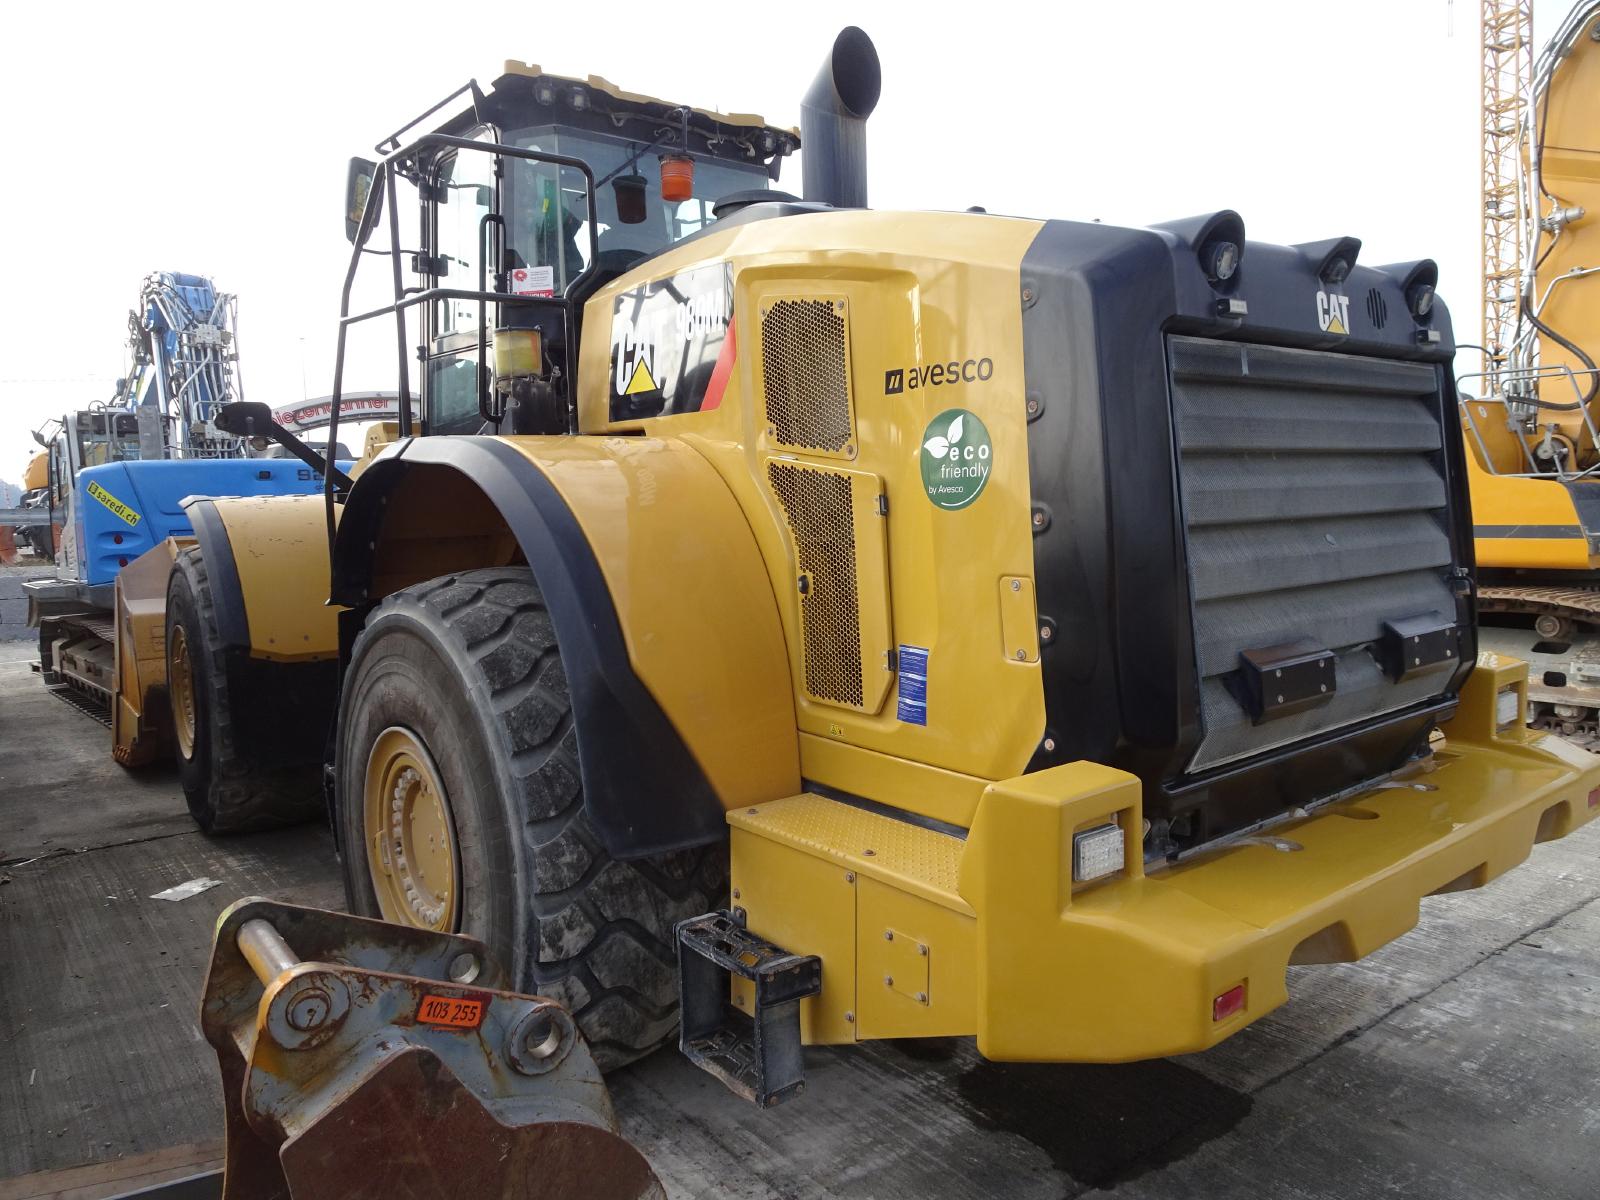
left=1170, top=338, right=1456, bottom=771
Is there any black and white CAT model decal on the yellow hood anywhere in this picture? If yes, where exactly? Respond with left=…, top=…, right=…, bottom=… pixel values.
left=611, top=262, right=733, bottom=421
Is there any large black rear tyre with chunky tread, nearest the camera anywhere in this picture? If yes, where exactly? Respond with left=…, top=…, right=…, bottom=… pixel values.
left=334, top=566, right=726, bottom=1070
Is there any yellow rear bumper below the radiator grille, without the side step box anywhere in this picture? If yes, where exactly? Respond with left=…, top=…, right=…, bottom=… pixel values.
left=962, top=656, right=1600, bottom=1062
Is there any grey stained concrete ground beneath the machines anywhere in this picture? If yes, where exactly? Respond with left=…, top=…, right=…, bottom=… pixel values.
left=0, top=643, right=1600, bottom=1200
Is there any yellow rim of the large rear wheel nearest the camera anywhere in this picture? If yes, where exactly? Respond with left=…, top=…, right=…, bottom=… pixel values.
left=362, top=725, right=461, bottom=933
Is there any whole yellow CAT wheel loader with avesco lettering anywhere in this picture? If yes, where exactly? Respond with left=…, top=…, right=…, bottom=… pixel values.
left=123, top=29, right=1600, bottom=1104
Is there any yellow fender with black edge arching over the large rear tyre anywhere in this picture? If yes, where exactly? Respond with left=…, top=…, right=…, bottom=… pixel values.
left=333, top=437, right=800, bottom=858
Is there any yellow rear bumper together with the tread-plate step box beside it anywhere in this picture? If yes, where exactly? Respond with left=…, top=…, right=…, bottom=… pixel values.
left=728, top=656, right=1600, bottom=1062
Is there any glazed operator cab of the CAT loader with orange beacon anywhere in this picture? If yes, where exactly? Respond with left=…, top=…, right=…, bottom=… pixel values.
left=346, top=62, right=800, bottom=434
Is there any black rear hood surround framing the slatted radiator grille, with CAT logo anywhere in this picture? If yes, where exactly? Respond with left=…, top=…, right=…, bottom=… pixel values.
left=1019, top=218, right=1475, bottom=850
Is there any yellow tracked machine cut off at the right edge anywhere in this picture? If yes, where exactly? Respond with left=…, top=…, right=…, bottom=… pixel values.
left=1461, top=0, right=1600, bottom=750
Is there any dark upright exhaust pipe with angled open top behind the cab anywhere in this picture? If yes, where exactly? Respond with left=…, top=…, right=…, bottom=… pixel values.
left=800, top=26, right=883, bottom=208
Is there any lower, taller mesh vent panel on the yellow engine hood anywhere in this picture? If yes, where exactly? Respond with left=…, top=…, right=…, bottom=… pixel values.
left=766, top=462, right=864, bottom=709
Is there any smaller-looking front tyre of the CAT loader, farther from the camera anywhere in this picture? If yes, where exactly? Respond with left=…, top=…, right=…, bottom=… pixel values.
left=166, top=547, right=323, bottom=834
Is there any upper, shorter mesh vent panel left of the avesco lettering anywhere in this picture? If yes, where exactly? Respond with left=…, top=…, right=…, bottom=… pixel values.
left=762, top=299, right=851, bottom=453
